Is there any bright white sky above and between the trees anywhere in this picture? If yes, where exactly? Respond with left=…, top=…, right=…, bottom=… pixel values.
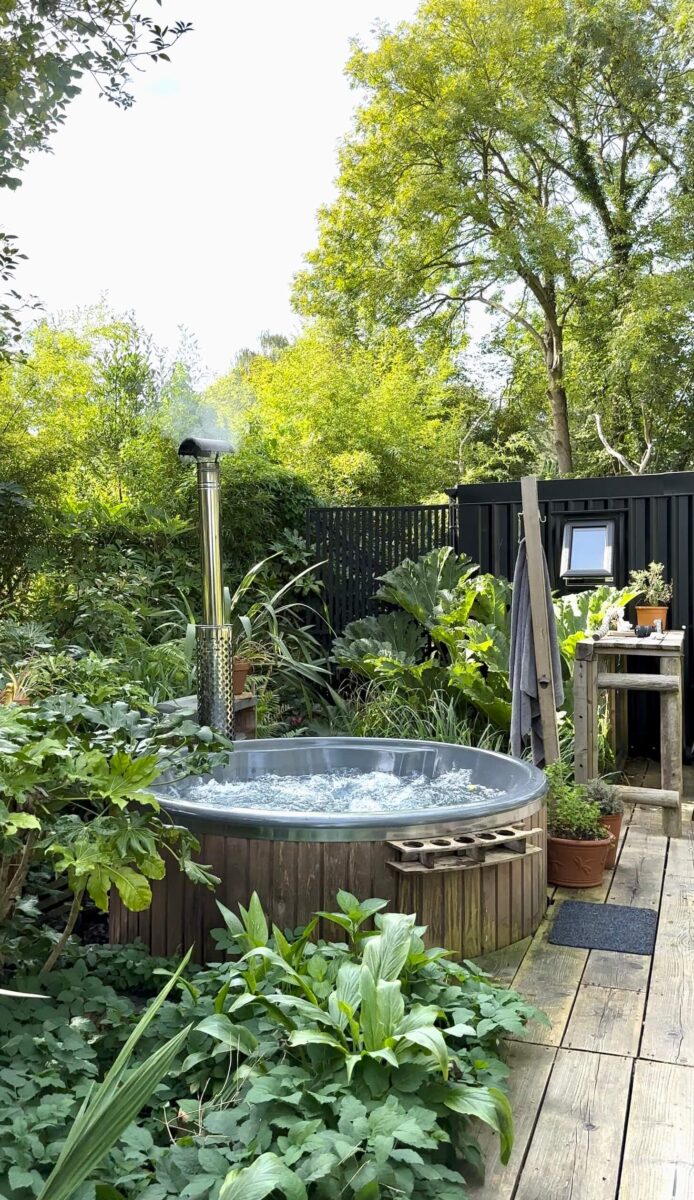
left=2, top=0, right=417, bottom=374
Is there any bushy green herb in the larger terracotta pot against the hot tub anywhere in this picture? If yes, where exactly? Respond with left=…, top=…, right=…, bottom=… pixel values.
left=548, top=764, right=612, bottom=888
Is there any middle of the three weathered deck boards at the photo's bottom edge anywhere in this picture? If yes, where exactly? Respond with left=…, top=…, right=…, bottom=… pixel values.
left=515, top=1050, right=639, bottom=1200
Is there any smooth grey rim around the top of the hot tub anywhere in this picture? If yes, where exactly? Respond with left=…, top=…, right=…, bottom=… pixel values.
left=152, top=737, right=548, bottom=842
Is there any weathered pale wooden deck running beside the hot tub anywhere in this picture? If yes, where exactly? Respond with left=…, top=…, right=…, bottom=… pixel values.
left=471, top=762, right=694, bottom=1200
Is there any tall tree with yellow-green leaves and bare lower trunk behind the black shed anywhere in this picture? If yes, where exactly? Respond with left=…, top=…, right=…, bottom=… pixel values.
left=298, top=0, right=693, bottom=473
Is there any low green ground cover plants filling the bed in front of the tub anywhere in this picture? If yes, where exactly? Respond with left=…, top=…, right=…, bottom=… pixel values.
left=0, top=893, right=538, bottom=1200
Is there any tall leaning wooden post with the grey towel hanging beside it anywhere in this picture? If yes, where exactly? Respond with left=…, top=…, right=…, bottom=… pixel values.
left=521, top=475, right=560, bottom=763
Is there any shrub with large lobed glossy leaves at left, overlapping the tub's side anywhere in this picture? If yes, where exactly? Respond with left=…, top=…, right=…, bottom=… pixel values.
left=0, top=695, right=228, bottom=967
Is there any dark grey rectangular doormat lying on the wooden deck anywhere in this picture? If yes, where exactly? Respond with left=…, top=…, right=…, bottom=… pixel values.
left=548, top=900, right=658, bottom=954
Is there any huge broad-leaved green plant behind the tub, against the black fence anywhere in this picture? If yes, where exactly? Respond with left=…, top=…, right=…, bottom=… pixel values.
left=333, top=547, right=638, bottom=752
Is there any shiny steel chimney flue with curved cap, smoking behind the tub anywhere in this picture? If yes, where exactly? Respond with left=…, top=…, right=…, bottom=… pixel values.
left=179, top=438, right=234, bottom=738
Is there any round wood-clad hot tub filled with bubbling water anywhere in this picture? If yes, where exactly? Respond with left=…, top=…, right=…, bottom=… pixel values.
left=110, top=737, right=546, bottom=959
